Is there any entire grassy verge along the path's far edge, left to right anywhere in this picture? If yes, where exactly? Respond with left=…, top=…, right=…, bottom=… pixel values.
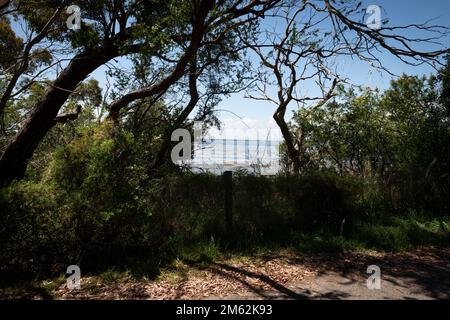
left=0, top=214, right=450, bottom=299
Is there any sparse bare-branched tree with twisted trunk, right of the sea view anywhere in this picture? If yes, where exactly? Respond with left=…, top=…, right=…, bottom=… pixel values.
left=244, top=0, right=449, bottom=172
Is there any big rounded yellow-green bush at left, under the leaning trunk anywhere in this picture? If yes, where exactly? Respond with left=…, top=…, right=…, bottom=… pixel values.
left=0, top=125, right=172, bottom=282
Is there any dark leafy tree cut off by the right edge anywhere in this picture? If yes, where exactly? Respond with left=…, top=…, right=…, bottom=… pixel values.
left=381, top=63, right=450, bottom=179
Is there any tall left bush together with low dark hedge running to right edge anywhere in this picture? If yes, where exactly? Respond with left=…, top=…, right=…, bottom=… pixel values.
left=0, top=125, right=450, bottom=279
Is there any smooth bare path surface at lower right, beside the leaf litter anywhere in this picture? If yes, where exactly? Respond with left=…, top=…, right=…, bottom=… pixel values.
left=212, top=249, right=450, bottom=300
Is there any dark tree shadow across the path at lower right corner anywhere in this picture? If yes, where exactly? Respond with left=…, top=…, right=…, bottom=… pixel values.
left=270, top=248, right=450, bottom=299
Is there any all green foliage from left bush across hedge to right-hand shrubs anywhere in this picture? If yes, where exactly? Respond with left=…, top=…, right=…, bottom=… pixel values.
left=0, top=47, right=450, bottom=281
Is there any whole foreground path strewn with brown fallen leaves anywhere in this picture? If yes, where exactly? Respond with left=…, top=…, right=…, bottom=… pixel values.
left=0, top=249, right=450, bottom=300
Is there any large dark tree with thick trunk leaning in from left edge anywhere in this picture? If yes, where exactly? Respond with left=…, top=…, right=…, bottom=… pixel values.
left=0, top=0, right=279, bottom=185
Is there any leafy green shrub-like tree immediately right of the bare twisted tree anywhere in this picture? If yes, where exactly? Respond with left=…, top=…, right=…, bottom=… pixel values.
left=292, top=89, right=395, bottom=177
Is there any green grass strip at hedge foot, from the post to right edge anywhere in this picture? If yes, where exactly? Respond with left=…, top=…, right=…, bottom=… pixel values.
left=174, top=214, right=450, bottom=258
